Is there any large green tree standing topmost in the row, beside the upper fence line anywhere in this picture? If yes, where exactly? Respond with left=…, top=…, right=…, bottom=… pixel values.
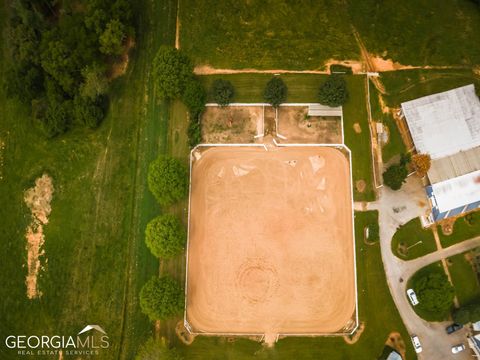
left=153, top=46, right=193, bottom=99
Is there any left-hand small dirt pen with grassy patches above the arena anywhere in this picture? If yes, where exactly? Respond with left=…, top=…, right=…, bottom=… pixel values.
left=202, top=106, right=263, bottom=144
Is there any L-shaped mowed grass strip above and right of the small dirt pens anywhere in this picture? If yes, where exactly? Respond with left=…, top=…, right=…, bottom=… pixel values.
left=200, top=74, right=375, bottom=201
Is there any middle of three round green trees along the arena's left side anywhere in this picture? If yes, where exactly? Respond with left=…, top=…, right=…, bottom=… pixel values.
left=145, top=214, right=187, bottom=259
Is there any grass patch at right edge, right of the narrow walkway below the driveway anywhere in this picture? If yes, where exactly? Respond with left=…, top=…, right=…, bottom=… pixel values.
left=448, top=252, right=480, bottom=305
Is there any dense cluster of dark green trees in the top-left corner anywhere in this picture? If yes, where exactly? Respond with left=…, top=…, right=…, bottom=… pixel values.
left=5, top=0, right=134, bottom=138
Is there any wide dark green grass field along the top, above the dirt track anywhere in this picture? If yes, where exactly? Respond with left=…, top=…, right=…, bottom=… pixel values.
left=180, top=0, right=480, bottom=70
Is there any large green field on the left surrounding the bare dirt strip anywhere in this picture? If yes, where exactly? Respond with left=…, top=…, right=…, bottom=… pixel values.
left=0, top=1, right=176, bottom=359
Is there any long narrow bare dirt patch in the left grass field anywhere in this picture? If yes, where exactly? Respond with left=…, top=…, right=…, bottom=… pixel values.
left=24, top=174, right=53, bottom=299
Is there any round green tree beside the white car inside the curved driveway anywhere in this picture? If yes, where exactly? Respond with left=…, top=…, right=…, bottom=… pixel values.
left=414, top=273, right=455, bottom=314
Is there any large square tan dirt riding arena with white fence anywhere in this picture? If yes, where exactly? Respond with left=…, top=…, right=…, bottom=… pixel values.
left=186, top=147, right=356, bottom=337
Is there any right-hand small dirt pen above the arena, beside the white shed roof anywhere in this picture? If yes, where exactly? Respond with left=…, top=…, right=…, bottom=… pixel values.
left=278, top=106, right=342, bottom=144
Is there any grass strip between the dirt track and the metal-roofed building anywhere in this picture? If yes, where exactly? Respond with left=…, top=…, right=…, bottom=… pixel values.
left=380, top=69, right=480, bottom=107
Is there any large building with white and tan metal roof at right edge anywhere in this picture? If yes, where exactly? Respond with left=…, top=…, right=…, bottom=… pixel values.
left=402, top=84, right=480, bottom=221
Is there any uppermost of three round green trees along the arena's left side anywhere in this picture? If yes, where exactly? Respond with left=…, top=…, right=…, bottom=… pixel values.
left=147, top=155, right=188, bottom=206
